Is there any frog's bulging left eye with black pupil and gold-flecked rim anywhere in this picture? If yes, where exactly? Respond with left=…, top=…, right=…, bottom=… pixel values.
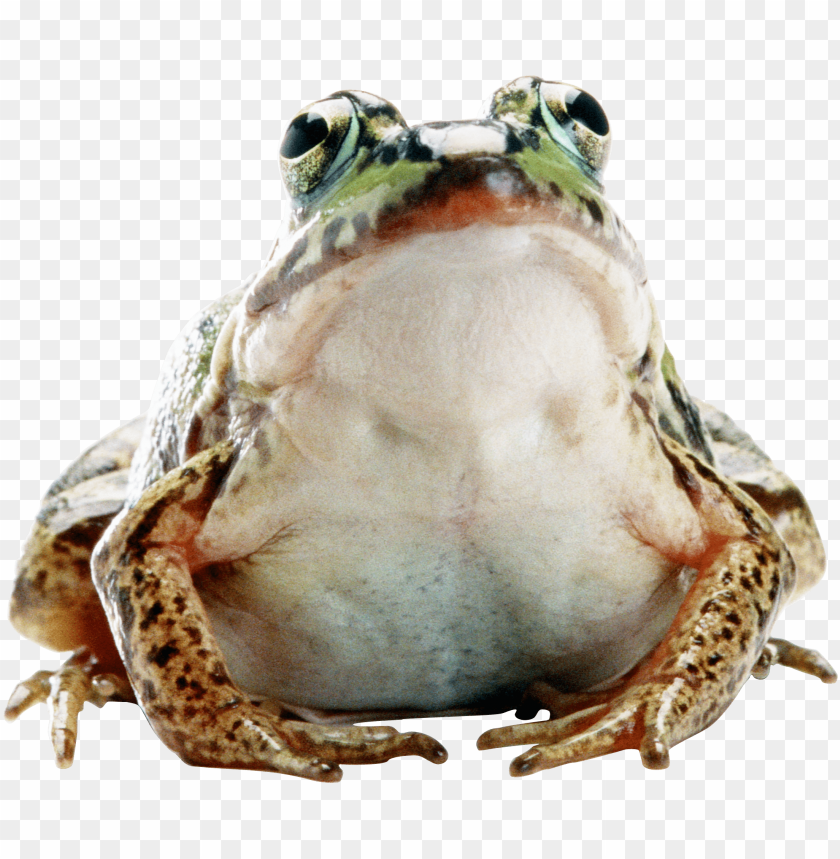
left=280, top=91, right=405, bottom=197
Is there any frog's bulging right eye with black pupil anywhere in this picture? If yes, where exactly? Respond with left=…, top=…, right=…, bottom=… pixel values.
left=540, top=81, right=610, bottom=173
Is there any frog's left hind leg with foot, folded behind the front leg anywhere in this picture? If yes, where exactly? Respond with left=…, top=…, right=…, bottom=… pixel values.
left=5, top=418, right=144, bottom=767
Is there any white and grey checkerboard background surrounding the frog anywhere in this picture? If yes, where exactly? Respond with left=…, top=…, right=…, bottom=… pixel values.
left=0, top=0, right=840, bottom=859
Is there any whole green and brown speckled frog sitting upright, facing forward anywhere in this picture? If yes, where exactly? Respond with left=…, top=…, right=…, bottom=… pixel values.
left=6, top=76, right=837, bottom=782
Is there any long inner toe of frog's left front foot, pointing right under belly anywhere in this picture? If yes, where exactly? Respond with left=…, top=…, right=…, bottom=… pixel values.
left=283, top=721, right=448, bottom=764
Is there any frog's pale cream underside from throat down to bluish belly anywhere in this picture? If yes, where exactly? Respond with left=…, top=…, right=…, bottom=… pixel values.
left=190, top=224, right=703, bottom=719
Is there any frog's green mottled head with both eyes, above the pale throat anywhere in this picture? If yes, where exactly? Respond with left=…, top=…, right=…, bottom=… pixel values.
left=247, top=77, right=645, bottom=312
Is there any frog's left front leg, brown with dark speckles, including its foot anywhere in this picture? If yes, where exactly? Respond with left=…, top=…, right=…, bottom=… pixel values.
left=93, top=442, right=446, bottom=781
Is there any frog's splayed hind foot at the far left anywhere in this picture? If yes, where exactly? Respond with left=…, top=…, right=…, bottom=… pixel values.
left=5, top=648, right=131, bottom=769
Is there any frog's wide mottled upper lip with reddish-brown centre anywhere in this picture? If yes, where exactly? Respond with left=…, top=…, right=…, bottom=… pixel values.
left=246, top=153, right=645, bottom=313
